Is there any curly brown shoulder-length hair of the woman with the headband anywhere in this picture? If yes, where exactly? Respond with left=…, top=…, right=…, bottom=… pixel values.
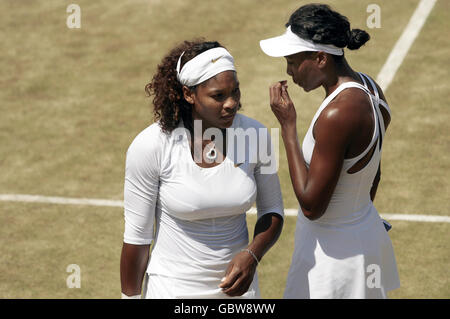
left=145, top=39, right=222, bottom=133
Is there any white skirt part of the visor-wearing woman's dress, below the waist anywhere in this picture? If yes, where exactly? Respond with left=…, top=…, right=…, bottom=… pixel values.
left=284, top=205, right=400, bottom=299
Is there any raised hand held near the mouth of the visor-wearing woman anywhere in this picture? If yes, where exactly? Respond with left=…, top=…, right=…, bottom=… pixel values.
left=269, top=80, right=297, bottom=130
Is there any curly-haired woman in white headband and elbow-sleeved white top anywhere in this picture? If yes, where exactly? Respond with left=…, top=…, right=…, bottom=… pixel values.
left=120, top=41, right=283, bottom=299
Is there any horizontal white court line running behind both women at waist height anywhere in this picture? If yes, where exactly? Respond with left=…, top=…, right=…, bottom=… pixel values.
left=0, top=194, right=450, bottom=223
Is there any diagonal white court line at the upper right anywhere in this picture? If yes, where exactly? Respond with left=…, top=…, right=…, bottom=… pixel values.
left=377, top=0, right=436, bottom=91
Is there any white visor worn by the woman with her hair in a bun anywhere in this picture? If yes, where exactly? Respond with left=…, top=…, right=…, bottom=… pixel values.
left=259, top=26, right=344, bottom=57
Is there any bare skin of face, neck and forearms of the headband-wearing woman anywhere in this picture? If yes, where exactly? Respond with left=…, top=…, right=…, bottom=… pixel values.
left=120, top=71, right=283, bottom=297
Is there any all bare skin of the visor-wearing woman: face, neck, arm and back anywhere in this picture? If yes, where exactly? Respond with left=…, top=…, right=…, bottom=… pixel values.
left=270, top=52, right=390, bottom=220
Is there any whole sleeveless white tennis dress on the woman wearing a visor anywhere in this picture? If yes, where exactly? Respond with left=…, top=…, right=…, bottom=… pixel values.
left=284, top=74, right=400, bottom=298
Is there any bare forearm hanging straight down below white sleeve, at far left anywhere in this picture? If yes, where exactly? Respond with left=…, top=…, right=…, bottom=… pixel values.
left=120, top=243, right=150, bottom=296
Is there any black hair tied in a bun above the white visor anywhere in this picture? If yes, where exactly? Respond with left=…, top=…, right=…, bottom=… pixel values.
left=286, top=4, right=370, bottom=50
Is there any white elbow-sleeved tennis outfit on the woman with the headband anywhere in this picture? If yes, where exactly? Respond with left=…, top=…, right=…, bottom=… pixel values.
left=124, top=114, right=283, bottom=298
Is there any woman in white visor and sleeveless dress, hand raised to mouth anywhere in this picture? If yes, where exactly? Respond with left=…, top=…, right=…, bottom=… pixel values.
left=260, top=4, right=400, bottom=298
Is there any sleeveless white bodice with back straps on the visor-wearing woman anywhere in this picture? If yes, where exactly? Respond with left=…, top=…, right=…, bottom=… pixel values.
left=300, top=73, right=390, bottom=224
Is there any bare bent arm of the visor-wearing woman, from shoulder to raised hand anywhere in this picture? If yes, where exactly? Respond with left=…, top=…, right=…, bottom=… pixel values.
left=270, top=82, right=366, bottom=220
